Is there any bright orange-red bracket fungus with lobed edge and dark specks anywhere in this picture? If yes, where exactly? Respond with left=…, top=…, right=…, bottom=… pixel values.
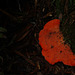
left=39, top=19, right=75, bottom=66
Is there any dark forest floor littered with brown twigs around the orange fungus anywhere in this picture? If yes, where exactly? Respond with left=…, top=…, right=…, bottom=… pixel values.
left=0, top=0, right=75, bottom=75
